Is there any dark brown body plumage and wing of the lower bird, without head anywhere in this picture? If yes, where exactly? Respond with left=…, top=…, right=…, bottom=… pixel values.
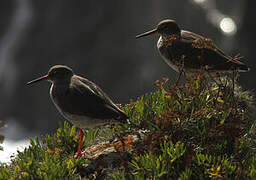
left=51, top=75, right=127, bottom=119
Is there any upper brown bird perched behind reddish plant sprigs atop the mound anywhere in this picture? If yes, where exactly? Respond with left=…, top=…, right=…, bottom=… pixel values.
left=136, top=19, right=249, bottom=77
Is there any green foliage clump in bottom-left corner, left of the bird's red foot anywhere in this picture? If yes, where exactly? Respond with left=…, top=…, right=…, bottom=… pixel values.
left=0, top=122, right=91, bottom=179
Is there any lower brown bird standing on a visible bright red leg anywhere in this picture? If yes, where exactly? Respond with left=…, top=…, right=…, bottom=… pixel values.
left=27, top=65, right=128, bottom=158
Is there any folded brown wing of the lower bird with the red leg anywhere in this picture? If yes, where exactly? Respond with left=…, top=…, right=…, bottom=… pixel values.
left=66, top=76, right=127, bottom=120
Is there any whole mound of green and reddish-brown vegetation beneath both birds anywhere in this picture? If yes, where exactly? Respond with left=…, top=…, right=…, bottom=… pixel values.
left=0, top=76, right=256, bottom=179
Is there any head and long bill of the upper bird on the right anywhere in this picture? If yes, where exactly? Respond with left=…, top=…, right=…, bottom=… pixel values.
left=136, top=19, right=180, bottom=38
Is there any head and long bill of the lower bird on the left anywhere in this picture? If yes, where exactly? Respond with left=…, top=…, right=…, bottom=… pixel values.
left=27, top=65, right=74, bottom=85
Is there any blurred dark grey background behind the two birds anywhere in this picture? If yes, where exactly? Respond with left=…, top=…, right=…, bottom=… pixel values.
left=0, top=0, right=256, bottom=139
